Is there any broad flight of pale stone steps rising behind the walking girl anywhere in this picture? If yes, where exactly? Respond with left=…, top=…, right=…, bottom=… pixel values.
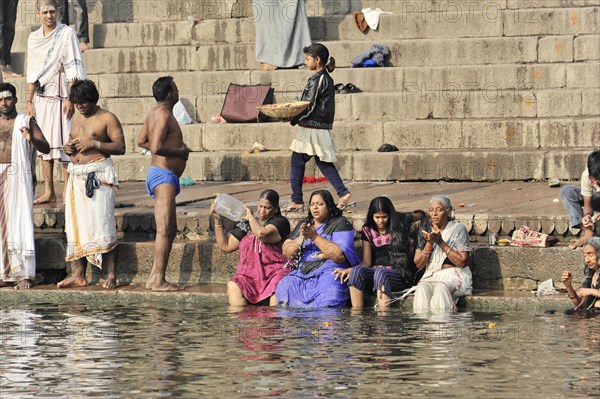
left=14, top=0, right=600, bottom=181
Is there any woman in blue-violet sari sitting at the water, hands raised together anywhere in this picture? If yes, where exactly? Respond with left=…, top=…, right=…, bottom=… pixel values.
left=276, top=190, right=360, bottom=308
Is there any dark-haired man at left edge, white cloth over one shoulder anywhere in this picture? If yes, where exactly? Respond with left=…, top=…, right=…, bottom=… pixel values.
left=0, top=83, right=50, bottom=289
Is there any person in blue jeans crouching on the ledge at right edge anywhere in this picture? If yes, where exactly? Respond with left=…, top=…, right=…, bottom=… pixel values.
left=560, top=150, right=600, bottom=249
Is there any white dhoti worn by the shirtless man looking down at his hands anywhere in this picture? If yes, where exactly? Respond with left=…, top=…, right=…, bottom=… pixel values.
left=65, top=158, right=119, bottom=268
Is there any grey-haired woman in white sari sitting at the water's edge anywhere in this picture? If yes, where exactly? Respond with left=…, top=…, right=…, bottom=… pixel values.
left=413, top=195, right=473, bottom=312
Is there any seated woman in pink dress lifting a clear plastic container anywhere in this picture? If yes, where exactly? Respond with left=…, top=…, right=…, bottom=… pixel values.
left=210, top=190, right=290, bottom=306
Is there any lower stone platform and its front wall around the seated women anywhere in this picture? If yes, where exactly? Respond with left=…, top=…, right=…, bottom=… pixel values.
left=29, top=182, right=582, bottom=290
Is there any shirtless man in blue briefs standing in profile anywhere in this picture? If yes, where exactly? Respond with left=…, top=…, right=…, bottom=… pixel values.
left=137, top=76, right=190, bottom=291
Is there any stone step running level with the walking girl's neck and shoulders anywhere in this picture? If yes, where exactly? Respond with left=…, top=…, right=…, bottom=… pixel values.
left=10, top=61, right=600, bottom=102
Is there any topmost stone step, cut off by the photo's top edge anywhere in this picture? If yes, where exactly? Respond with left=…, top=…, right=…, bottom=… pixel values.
left=17, top=0, right=600, bottom=25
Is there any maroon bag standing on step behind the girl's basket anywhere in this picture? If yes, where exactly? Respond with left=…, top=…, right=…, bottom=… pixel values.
left=221, top=83, right=274, bottom=123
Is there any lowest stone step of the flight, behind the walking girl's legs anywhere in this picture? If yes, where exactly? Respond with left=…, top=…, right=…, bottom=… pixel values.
left=29, top=147, right=590, bottom=182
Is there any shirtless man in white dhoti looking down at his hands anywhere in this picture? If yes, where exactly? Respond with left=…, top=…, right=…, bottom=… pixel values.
left=58, top=80, right=125, bottom=289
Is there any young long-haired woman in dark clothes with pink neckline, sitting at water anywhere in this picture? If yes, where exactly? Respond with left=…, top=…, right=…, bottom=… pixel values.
left=334, top=197, right=415, bottom=308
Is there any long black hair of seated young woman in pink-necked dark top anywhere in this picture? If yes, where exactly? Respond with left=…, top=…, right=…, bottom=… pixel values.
left=365, top=197, right=414, bottom=270
